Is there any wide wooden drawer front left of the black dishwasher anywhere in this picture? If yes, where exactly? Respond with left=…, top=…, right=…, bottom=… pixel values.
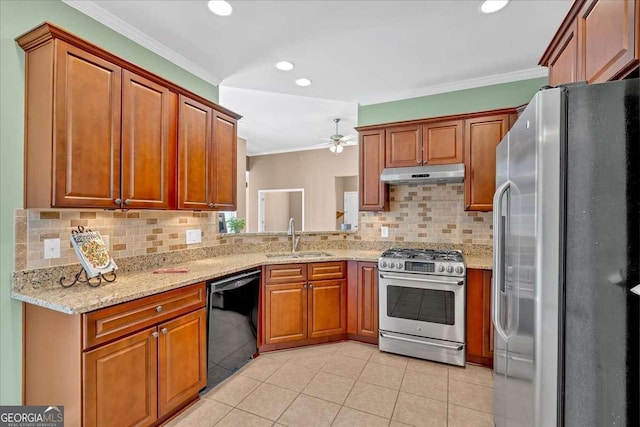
left=82, top=283, right=206, bottom=349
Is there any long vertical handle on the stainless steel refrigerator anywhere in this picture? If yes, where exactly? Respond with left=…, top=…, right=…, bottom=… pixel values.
left=491, top=181, right=511, bottom=341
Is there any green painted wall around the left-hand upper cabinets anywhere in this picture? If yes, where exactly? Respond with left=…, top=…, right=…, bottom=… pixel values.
left=0, top=0, right=218, bottom=405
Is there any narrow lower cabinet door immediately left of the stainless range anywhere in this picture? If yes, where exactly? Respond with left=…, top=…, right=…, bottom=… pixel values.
left=356, top=262, right=378, bottom=342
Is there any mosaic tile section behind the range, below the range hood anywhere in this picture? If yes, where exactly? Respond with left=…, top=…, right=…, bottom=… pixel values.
left=358, top=184, right=493, bottom=245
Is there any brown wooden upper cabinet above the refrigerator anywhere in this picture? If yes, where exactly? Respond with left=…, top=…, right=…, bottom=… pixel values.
left=539, top=0, right=640, bottom=86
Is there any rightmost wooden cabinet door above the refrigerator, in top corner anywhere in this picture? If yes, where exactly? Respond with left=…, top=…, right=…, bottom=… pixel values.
left=578, top=0, right=640, bottom=83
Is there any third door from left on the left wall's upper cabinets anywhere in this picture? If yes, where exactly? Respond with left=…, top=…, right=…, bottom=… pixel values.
left=178, top=95, right=213, bottom=210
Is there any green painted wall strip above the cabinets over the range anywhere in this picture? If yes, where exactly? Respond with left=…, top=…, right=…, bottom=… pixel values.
left=358, top=77, right=547, bottom=126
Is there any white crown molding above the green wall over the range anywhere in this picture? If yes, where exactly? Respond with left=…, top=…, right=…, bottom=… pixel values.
left=358, top=67, right=549, bottom=106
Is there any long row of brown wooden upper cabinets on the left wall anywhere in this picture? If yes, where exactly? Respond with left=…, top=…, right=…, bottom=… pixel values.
left=16, top=23, right=240, bottom=210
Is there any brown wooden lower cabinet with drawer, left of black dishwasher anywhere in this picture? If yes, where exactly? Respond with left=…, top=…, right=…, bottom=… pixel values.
left=23, top=283, right=207, bottom=427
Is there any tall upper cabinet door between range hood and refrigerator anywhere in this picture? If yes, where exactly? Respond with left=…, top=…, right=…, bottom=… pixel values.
left=464, top=114, right=509, bottom=211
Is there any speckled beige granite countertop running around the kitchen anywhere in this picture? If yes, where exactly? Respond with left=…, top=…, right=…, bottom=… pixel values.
left=11, top=249, right=492, bottom=314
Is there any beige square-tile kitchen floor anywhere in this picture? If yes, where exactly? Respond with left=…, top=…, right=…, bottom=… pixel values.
left=169, top=341, right=493, bottom=427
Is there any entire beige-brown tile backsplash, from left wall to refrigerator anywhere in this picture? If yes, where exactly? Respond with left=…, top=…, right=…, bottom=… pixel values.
left=15, top=184, right=493, bottom=271
